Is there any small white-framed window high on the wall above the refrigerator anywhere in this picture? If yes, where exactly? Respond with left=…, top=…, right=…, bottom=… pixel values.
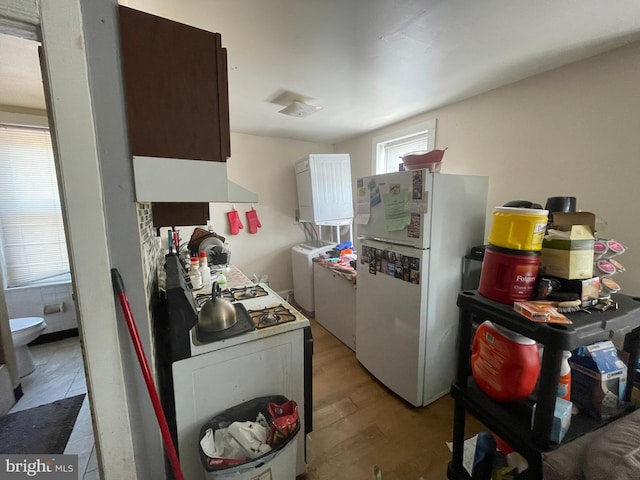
left=374, top=120, right=435, bottom=174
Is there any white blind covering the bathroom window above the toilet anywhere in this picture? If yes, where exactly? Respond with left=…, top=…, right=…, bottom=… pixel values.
left=0, top=125, right=69, bottom=287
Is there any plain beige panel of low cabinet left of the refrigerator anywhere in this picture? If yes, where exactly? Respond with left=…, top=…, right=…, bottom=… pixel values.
left=313, top=262, right=356, bottom=351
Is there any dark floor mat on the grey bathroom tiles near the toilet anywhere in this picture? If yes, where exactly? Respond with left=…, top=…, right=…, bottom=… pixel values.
left=0, top=393, right=85, bottom=455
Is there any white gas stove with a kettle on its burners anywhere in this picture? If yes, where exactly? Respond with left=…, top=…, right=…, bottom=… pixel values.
left=171, top=278, right=313, bottom=480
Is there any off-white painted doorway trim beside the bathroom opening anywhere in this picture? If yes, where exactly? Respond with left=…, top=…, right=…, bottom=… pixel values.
left=0, top=0, right=137, bottom=480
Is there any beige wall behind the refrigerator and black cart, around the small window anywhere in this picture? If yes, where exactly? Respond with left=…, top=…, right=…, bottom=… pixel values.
left=335, top=43, right=640, bottom=295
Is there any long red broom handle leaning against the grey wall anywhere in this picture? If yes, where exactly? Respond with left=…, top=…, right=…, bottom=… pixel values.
left=111, top=268, right=184, bottom=480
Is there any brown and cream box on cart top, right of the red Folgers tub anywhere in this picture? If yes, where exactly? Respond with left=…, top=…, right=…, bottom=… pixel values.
left=540, top=212, right=596, bottom=280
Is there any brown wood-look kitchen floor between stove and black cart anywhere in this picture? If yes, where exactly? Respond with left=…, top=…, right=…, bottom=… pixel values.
left=298, top=320, right=484, bottom=480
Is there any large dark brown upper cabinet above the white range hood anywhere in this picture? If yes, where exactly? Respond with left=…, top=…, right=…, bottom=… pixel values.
left=119, top=6, right=231, bottom=162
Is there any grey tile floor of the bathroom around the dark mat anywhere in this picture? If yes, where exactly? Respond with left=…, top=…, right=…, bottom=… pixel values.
left=9, top=337, right=100, bottom=480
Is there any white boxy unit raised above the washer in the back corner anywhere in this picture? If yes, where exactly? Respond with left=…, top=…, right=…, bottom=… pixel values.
left=296, top=153, right=353, bottom=225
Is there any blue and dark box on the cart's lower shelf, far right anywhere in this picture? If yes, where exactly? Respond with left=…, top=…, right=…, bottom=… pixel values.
left=569, top=340, right=627, bottom=417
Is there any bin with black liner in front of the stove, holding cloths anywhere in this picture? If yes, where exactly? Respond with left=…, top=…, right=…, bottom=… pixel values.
left=198, top=395, right=300, bottom=480
